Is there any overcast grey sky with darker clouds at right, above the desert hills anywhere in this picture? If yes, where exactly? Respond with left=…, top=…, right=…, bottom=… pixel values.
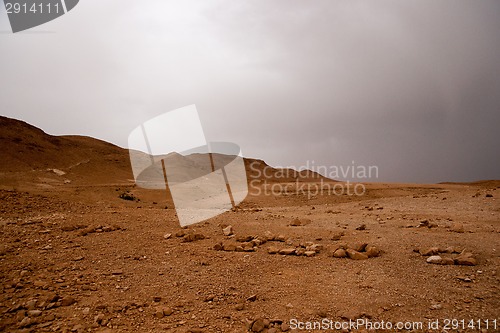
left=0, top=0, right=500, bottom=182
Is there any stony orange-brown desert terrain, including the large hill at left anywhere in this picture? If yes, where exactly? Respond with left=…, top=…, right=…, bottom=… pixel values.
left=0, top=117, right=500, bottom=333
